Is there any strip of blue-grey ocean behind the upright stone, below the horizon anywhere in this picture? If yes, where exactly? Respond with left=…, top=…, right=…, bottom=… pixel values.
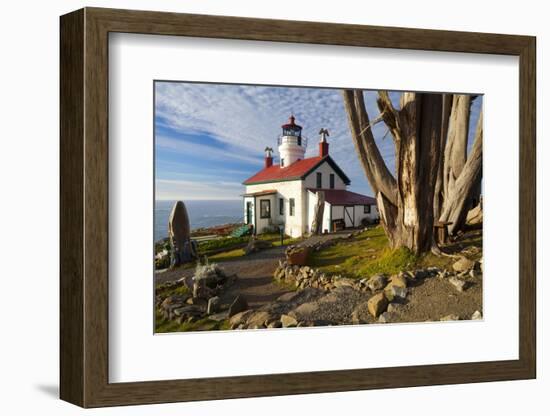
left=154, top=200, right=243, bottom=241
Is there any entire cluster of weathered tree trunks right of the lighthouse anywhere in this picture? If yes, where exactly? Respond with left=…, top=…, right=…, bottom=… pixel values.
left=342, top=90, right=483, bottom=254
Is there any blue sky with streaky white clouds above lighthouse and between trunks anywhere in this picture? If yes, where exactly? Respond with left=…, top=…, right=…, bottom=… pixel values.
left=155, top=82, right=482, bottom=201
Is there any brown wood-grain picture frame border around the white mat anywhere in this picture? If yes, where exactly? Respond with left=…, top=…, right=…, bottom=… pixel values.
left=60, top=8, right=536, bottom=407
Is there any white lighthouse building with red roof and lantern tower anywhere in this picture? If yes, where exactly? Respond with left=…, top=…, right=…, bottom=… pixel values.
left=243, top=116, right=378, bottom=237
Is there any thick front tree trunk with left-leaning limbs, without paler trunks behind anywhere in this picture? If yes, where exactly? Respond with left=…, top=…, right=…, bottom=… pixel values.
left=343, top=90, right=443, bottom=254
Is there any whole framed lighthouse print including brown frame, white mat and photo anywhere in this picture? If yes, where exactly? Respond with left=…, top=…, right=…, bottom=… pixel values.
left=60, top=8, right=536, bottom=407
